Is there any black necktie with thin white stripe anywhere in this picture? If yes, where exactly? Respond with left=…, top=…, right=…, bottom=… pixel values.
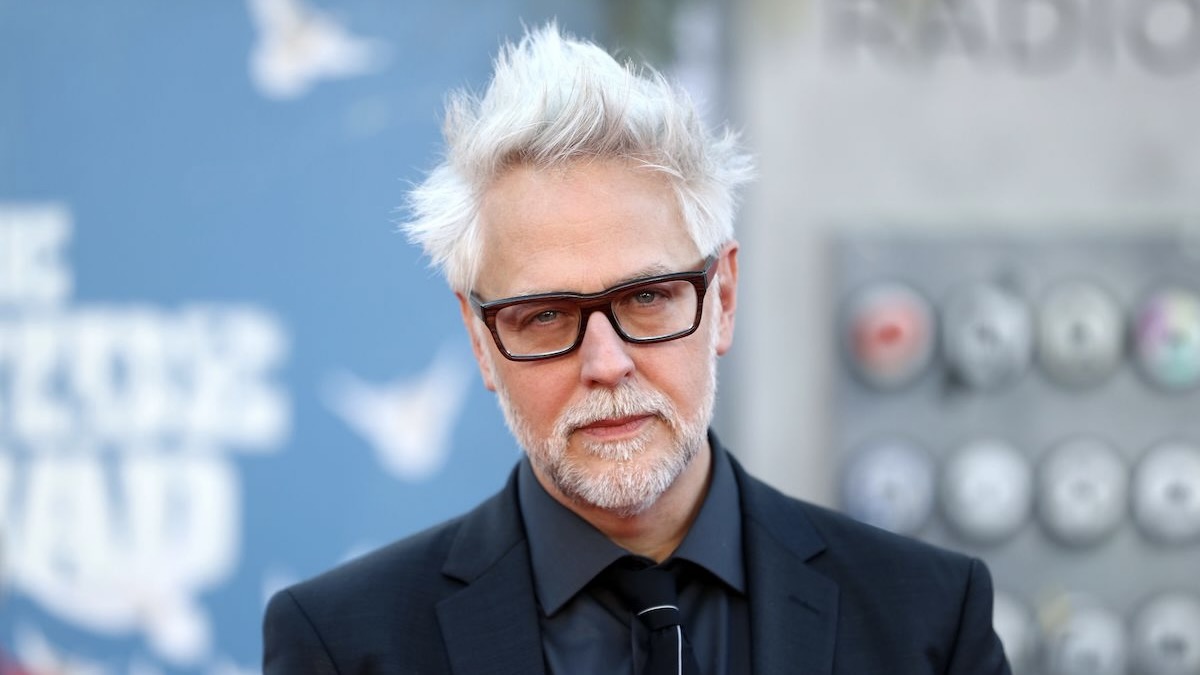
left=607, top=556, right=700, bottom=675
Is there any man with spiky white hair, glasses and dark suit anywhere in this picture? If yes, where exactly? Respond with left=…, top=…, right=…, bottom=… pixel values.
left=264, top=25, right=1008, bottom=675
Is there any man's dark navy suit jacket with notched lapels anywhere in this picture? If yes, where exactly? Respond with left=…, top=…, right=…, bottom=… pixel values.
left=263, top=446, right=1009, bottom=675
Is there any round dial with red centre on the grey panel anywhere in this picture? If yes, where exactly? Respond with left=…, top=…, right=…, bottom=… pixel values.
left=842, top=282, right=936, bottom=389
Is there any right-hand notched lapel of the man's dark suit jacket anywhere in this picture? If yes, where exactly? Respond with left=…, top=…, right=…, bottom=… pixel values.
left=733, top=454, right=838, bottom=675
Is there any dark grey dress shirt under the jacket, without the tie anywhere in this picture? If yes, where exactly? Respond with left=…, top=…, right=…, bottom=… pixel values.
left=517, top=443, right=750, bottom=675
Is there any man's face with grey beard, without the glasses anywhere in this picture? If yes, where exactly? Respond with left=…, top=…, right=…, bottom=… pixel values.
left=460, top=160, right=737, bottom=515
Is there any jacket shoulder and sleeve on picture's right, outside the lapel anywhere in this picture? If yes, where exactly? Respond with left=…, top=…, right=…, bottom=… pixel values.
left=743, top=468, right=1008, bottom=675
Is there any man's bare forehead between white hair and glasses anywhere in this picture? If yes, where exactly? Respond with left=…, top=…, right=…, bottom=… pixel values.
left=475, top=160, right=701, bottom=299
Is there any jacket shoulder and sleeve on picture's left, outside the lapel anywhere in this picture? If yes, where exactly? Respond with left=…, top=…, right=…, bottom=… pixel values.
left=263, top=473, right=523, bottom=675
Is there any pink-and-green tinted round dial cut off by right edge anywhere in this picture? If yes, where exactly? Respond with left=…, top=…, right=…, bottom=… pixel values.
left=1134, top=288, right=1200, bottom=390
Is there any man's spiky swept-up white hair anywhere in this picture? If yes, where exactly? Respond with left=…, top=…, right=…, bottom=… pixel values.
left=401, top=23, right=754, bottom=292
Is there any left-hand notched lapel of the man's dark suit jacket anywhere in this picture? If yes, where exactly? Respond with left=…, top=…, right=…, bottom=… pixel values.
left=438, top=473, right=545, bottom=675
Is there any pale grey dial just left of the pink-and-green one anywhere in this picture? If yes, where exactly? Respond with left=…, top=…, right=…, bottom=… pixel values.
left=1038, top=281, right=1124, bottom=387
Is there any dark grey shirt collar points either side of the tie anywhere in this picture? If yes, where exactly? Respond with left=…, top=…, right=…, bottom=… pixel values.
left=517, top=435, right=745, bottom=616
